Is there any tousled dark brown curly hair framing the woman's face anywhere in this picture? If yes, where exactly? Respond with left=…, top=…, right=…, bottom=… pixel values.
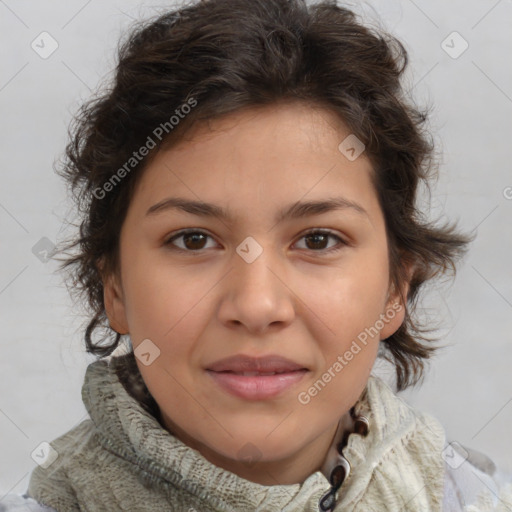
left=56, top=0, right=472, bottom=390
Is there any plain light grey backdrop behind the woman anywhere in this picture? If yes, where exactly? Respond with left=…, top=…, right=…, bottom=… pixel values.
left=0, top=0, right=512, bottom=498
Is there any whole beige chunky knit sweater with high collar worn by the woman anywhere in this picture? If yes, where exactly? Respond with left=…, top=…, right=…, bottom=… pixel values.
left=28, top=354, right=512, bottom=512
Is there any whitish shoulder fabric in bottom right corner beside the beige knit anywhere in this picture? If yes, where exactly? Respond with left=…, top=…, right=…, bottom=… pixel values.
left=443, top=441, right=512, bottom=512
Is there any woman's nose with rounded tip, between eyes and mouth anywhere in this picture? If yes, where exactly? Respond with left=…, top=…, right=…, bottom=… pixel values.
left=218, top=249, right=296, bottom=334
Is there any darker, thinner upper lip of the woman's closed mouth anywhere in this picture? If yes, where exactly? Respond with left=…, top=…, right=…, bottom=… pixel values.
left=207, top=354, right=307, bottom=373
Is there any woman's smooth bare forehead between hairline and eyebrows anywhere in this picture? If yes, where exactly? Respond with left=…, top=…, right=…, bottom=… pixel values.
left=125, top=103, right=378, bottom=224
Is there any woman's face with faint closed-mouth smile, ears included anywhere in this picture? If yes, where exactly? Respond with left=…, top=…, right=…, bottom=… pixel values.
left=105, top=103, right=404, bottom=485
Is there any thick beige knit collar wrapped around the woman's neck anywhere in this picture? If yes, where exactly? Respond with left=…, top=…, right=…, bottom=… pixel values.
left=82, top=356, right=444, bottom=512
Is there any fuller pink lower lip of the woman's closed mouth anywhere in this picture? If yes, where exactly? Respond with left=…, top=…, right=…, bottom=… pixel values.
left=206, top=370, right=307, bottom=400
